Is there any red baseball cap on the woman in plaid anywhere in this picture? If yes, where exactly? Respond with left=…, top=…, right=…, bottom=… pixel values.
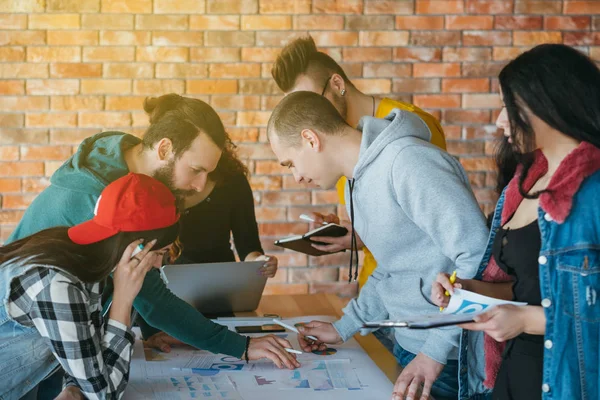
left=68, top=173, right=179, bottom=244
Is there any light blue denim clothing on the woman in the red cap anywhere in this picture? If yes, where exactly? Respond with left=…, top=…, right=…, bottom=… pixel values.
left=0, top=263, right=58, bottom=400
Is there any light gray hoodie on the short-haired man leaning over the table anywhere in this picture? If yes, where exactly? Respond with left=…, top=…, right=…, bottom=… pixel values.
left=334, top=109, right=488, bottom=364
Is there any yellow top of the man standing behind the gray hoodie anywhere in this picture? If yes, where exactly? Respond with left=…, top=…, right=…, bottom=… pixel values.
left=336, top=98, right=446, bottom=288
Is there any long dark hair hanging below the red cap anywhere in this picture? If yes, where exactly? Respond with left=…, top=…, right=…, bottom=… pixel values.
left=0, top=223, right=179, bottom=283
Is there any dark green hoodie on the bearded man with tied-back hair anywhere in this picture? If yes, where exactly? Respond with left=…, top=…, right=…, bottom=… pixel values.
left=7, top=132, right=246, bottom=357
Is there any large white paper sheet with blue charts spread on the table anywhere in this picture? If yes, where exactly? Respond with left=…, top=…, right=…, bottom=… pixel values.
left=124, top=316, right=392, bottom=400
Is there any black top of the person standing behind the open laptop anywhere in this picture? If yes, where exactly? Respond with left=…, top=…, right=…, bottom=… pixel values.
left=177, top=174, right=263, bottom=263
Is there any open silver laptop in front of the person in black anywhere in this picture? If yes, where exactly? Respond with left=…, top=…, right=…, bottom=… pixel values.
left=163, top=261, right=267, bottom=314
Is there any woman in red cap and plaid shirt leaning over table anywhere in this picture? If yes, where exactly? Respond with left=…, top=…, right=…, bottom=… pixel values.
left=0, top=174, right=179, bottom=399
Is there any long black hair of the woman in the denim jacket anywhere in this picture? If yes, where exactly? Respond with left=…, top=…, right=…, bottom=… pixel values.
left=496, top=44, right=600, bottom=199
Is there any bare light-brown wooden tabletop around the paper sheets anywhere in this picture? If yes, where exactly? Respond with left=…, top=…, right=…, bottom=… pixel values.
left=236, top=293, right=401, bottom=383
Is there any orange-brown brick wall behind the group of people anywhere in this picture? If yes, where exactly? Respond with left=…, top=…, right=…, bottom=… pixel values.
left=0, top=0, right=600, bottom=294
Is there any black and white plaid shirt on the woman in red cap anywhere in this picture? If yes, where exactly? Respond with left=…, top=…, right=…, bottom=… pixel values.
left=7, top=267, right=134, bottom=399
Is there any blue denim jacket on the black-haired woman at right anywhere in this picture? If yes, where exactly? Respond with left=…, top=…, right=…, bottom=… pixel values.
left=459, top=171, right=600, bottom=400
